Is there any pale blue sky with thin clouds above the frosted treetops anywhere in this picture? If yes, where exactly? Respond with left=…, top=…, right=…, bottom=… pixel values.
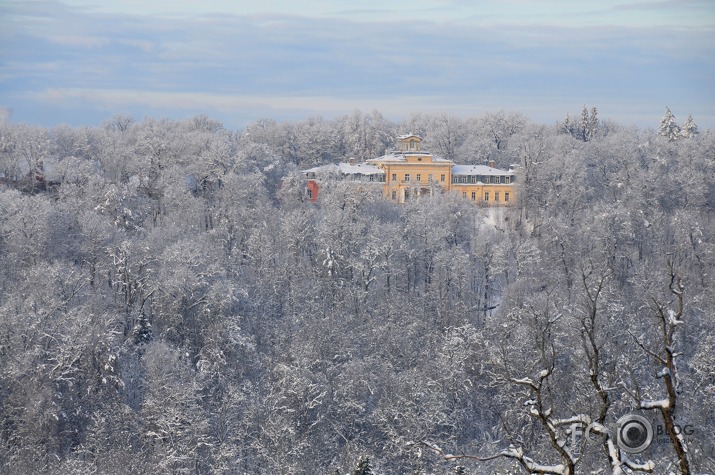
left=0, top=0, right=715, bottom=128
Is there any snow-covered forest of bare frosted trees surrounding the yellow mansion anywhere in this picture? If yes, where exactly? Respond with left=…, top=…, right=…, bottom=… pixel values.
left=0, top=107, right=715, bottom=474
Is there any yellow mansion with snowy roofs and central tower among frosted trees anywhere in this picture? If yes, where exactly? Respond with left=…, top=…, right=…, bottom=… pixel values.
left=304, top=134, right=516, bottom=206
